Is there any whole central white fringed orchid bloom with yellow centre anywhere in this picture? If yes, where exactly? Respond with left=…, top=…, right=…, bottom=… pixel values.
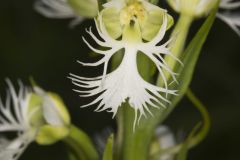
left=69, top=0, right=181, bottom=128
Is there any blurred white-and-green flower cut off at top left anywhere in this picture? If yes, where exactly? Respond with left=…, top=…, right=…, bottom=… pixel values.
left=35, top=0, right=97, bottom=26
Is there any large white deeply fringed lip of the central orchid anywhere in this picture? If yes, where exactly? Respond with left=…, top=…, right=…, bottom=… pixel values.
left=69, top=12, right=182, bottom=128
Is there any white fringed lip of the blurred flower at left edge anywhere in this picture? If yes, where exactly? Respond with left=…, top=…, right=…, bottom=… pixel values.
left=0, top=80, right=38, bottom=160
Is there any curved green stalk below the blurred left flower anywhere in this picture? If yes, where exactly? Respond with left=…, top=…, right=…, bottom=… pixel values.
left=63, top=125, right=98, bottom=160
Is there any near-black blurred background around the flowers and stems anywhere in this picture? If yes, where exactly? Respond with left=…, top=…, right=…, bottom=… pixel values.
left=0, top=0, right=240, bottom=160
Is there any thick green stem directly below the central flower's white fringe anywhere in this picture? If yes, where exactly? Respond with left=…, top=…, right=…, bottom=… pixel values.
left=114, top=103, right=154, bottom=160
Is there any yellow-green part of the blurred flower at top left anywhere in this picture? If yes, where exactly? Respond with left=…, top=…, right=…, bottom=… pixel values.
left=68, top=0, right=98, bottom=18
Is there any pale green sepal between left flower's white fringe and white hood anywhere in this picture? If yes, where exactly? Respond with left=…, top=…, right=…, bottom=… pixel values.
left=27, top=93, right=45, bottom=127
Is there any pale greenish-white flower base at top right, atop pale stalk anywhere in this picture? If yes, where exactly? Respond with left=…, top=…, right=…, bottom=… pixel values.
left=167, top=0, right=218, bottom=18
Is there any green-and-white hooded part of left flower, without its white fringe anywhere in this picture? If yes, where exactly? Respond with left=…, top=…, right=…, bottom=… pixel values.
left=30, top=85, right=70, bottom=145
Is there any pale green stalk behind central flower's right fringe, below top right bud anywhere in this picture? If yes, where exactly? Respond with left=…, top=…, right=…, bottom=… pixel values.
left=157, top=14, right=193, bottom=86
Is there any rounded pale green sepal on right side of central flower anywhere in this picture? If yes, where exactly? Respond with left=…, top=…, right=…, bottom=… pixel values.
left=141, top=9, right=174, bottom=41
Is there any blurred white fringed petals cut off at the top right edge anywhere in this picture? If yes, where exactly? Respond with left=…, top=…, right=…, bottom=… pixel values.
left=217, top=0, right=240, bottom=36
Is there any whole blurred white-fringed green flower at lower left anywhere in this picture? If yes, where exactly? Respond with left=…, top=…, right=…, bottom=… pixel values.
left=0, top=80, right=69, bottom=160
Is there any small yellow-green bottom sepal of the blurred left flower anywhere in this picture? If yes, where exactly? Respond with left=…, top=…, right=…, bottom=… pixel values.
left=36, top=125, right=69, bottom=145
